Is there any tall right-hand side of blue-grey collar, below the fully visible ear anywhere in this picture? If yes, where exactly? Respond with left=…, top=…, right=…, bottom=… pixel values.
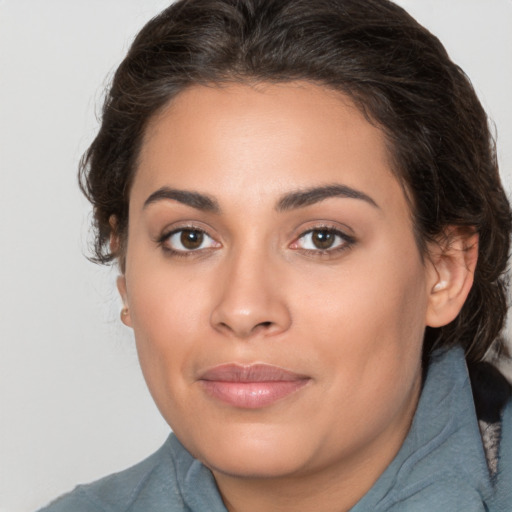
left=352, top=347, right=493, bottom=512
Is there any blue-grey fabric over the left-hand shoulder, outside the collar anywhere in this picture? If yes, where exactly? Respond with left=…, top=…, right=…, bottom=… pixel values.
left=35, top=436, right=188, bottom=512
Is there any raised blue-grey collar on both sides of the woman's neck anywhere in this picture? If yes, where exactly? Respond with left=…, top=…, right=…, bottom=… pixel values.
left=169, top=347, right=493, bottom=512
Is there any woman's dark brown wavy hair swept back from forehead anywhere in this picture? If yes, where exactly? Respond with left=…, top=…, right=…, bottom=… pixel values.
left=80, top=0, right=511, bottom=362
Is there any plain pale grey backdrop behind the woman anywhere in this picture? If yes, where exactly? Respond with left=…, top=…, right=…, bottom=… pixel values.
left=0, top=0, right=512, bottom=512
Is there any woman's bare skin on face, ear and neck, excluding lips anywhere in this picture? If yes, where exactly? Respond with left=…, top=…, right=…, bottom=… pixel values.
left=118, top=83, right=477, bottom=512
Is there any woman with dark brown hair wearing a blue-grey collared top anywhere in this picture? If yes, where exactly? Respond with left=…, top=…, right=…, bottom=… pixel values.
left=40, top=0, right=512, bottom=512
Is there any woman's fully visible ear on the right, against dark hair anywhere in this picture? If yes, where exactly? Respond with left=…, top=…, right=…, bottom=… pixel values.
left=426, top=226, right=478, bottom=327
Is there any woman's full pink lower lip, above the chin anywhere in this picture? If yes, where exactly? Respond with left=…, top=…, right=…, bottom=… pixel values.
left=201, top=379, right=309, bottom=409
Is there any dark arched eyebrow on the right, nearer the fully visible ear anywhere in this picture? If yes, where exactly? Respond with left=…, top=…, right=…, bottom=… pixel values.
left=276, top=184, right=380, bottom=212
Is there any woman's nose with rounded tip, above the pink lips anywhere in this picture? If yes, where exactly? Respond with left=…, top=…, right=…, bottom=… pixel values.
left=211, top=249, right=292, bottom=339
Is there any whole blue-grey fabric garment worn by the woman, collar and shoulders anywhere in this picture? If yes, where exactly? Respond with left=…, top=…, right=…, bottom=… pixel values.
left=40, top=347, right=512, bottom=512
